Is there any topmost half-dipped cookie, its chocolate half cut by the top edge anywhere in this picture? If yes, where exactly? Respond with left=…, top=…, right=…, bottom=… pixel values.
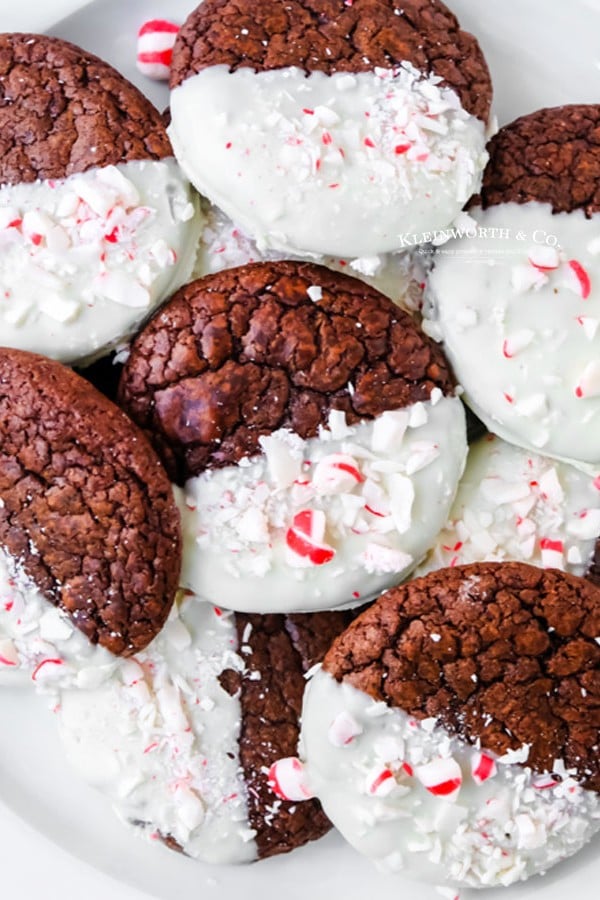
left=169, top=0, right=492, bottom=257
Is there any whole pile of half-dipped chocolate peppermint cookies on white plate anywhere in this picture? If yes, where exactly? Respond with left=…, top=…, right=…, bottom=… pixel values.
left=0, top=0, right=600, bottom=887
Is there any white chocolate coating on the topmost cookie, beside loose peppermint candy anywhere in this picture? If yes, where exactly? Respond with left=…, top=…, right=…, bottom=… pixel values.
left=168, top=63, right=487, bottom=258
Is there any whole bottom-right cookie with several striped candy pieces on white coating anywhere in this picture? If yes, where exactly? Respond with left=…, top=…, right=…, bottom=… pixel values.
left=301, top=563, right=600, bottom=887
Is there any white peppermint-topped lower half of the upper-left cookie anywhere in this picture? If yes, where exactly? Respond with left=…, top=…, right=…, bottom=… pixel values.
left=0, top=158, right=203, bottom=363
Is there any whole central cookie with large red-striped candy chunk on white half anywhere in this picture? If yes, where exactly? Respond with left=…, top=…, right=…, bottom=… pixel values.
left=119, top=262, right=466, bottom=613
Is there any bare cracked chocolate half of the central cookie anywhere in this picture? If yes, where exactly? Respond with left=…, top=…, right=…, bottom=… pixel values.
left=119, top=262, right=454, bottom=482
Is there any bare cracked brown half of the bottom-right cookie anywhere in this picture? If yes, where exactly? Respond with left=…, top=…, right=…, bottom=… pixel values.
left=324, top=563, right=600, bottom=791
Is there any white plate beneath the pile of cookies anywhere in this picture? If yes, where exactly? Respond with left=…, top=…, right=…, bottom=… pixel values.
left=0, top=0, right=600, bottom=900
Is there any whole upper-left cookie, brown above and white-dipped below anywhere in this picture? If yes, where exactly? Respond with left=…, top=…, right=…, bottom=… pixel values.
left=0, top=34, right=200, bottom=363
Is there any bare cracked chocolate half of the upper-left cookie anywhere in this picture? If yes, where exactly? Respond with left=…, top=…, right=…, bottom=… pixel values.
left=0, top=33, right=172, bottom=184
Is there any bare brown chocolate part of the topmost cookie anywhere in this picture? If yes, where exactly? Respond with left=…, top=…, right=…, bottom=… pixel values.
left=171, top=0, right=492, bottom=121
